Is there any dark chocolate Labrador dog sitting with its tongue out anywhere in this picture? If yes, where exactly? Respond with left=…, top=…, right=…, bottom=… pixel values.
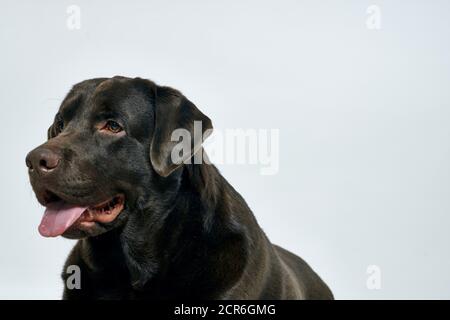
left=26, top=77, right=333, bottom=299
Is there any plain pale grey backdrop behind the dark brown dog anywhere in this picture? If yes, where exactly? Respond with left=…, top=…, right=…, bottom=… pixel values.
left=0, top=0, right=450, bottom=299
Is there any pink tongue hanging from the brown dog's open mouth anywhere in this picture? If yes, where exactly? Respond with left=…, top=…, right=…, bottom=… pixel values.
left=39, top=201, right=87, bottom=237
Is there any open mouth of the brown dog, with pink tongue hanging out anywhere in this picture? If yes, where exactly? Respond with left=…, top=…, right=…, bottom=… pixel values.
left=38, top=194, right=125, bottom=237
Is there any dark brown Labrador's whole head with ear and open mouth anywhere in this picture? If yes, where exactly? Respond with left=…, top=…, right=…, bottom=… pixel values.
left=26, top=77, right=212, bottom=238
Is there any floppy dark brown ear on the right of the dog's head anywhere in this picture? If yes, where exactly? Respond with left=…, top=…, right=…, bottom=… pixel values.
left=150, top=86, right=212, bottom=177
